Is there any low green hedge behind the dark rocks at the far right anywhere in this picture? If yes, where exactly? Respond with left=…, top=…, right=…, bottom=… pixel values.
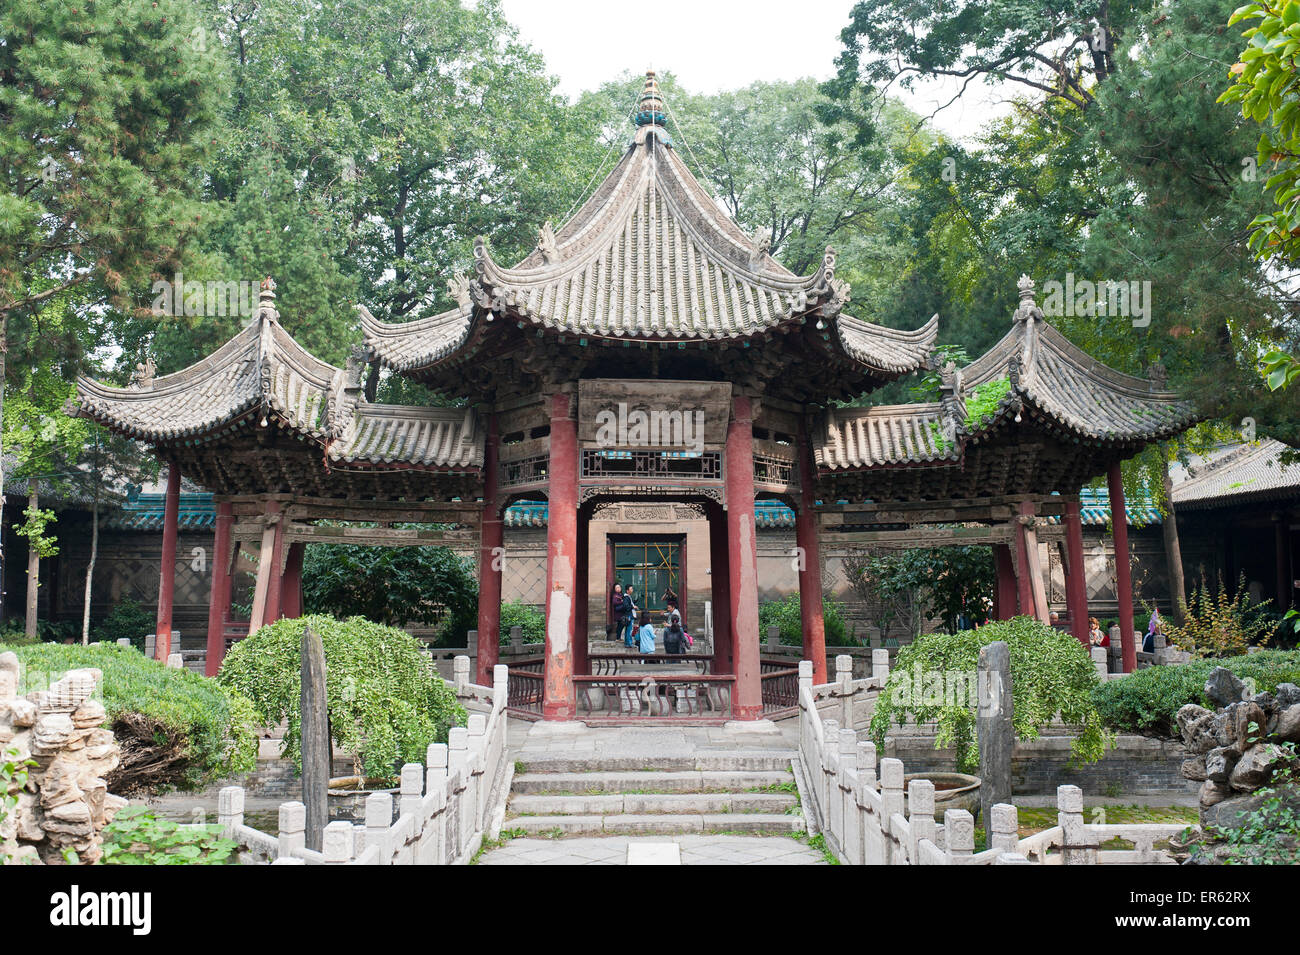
left=1093, top=650, right=1300, bottom=739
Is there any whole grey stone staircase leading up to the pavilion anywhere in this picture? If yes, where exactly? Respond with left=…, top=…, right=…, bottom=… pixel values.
left=502, top=752, right=803, bottom=835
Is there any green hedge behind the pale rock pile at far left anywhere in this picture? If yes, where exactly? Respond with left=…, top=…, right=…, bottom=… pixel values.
left=0, top=643, right=257, bottom=794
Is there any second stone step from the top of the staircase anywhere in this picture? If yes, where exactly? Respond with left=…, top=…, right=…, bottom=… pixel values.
left=511, top=761, right=794, bottom=799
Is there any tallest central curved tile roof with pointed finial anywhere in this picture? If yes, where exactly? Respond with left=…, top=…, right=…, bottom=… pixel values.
left=361, top=73, right=937, bottom=394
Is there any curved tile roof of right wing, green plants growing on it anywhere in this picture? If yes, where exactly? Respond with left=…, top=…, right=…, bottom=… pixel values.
left=814, top=277, right=1199, bottom=500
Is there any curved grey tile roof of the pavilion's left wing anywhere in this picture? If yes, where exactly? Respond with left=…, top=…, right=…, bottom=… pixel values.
left=68, top=281, right=485, bottom=496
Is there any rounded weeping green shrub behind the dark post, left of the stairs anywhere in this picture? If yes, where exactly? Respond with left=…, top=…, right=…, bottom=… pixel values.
left=217, top=616, right=464, bottom=780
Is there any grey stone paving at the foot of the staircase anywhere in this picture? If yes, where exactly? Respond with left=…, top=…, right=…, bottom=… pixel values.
left=477, top=835, right=826, bottom=865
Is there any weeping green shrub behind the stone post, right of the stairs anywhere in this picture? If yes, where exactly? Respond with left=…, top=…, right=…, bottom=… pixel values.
left=870, top=617, right=1106, bottom=773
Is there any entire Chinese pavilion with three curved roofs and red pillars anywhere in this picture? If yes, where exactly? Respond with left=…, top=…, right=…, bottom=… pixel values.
left=65, top=73, right=1195, bottom=720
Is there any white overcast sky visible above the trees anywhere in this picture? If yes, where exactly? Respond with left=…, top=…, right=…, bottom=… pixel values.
left=502, top=0, right=1001, bottom=138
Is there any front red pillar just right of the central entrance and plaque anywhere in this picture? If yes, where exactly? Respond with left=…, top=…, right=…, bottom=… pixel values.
left=724, top=395, right=763, bottom=720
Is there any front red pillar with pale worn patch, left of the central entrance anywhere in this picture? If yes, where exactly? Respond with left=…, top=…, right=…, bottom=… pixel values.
left=542, top=394, right=577, bottom=720
